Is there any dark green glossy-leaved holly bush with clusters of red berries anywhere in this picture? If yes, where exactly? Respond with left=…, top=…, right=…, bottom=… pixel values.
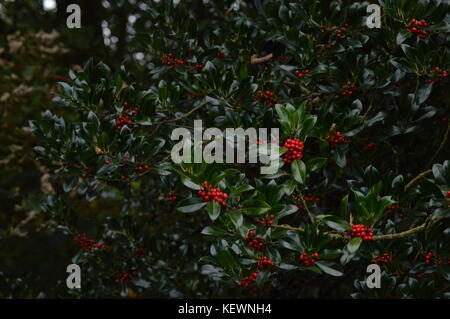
left=15, top=0, right=450, bottom=298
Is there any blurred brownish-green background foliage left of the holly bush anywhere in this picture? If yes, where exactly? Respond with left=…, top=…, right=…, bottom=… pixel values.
left=0, top=0, right=156, bottom=297
